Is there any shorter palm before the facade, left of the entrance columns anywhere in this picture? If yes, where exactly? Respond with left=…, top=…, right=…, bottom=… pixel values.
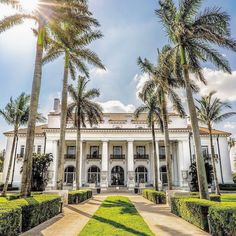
left=67, top=76, right=102, bottom=189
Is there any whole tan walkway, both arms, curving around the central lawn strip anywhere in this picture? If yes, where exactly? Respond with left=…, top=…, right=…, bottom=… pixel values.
left=22, top=193, right=209, bottom=236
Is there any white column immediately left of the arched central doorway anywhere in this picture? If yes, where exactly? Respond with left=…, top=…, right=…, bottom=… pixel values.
left=101, top=140, right=109, bottom=189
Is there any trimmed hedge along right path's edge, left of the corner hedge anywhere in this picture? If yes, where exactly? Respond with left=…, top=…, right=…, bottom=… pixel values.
left=171, top=196, right=219, bottom=231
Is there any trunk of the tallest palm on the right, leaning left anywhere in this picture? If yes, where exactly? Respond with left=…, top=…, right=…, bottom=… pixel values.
left=180, top=46, right=209, bottom=199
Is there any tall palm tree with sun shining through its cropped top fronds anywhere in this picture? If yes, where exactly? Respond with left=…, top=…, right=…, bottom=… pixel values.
left=0, top=0, right=99, bottom=197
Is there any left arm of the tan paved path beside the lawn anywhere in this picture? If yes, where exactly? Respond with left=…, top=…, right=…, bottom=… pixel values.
left=22, top=195, right=105, bottom=236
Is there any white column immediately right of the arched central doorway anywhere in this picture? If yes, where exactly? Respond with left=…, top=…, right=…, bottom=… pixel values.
left=127, top=140, right=135, bottom=190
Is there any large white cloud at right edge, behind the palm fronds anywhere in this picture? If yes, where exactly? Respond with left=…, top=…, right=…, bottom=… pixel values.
left=193, top=68, right=236, bottom=101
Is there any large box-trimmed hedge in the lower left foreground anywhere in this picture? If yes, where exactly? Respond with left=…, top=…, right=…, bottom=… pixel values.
left=0, top=195, right=61, bottom=235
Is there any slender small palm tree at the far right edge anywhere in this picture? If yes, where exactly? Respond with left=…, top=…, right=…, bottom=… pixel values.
left=196, top=91, right=236, bottom=194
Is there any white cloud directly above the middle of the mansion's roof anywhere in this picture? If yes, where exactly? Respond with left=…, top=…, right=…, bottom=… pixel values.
left=98, top=100, right=135, bottom=113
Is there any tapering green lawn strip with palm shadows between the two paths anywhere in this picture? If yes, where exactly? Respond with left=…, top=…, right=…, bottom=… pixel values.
left=79, top=196, right=154, bottom=236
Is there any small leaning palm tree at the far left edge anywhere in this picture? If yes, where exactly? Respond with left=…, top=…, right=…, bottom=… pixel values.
left=0, top=93, right=45, bottom=196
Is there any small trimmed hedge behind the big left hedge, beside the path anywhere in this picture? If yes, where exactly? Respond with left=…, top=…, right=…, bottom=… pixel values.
left=68, top=189, right=93, bottom=204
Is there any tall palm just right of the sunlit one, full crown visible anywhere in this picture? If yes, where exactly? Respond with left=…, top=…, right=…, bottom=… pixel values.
left=44, top=26, right=105, bottom=189
